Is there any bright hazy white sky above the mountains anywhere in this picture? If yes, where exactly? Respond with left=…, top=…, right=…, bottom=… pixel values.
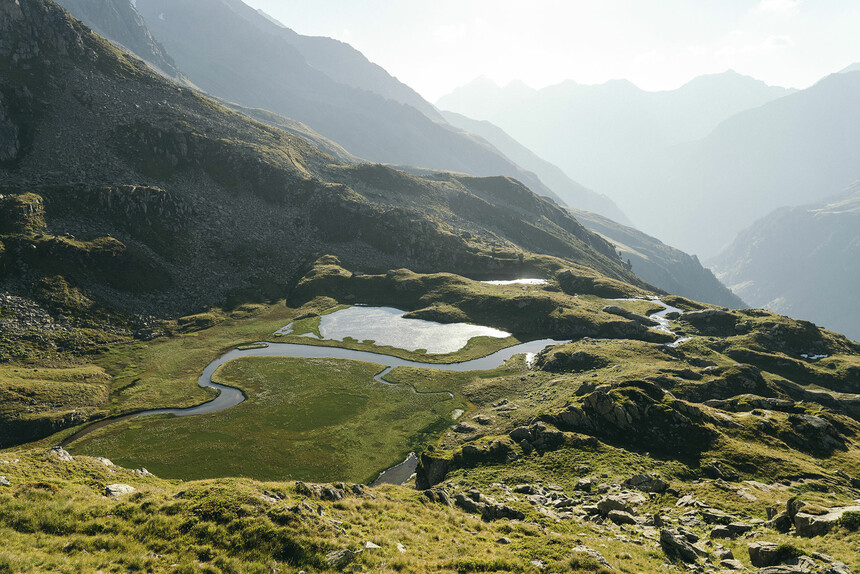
left=240, top=0, right=860, bottom=101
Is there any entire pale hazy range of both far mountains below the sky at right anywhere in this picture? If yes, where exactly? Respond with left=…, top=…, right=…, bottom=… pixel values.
left=438, top=68, right=860, bottom=256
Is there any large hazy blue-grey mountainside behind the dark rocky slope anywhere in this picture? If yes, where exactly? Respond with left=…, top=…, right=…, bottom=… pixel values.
left=95, top=0, right=557, bottom=206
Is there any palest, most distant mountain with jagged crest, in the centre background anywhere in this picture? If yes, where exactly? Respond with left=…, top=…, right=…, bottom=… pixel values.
left=437, top=71, right=791, bottom=216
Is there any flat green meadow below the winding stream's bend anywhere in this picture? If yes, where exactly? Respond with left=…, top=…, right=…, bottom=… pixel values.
left=69, top=358, right=464, bottom=481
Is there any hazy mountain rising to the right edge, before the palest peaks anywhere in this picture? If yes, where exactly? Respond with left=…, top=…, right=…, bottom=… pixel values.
left=635, top=72, right=860, bottom=255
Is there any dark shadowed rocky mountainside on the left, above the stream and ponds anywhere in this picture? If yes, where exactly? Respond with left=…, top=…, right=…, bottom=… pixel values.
left=0, top=0, right=641, bottom=332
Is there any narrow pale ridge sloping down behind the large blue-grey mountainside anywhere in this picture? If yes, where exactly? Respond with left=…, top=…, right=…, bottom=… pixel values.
left=442, top=112, right=629, bottom=223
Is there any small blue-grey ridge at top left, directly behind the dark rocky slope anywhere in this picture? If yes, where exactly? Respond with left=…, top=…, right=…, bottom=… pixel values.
left=53, top=0, right=185, bottom=82
